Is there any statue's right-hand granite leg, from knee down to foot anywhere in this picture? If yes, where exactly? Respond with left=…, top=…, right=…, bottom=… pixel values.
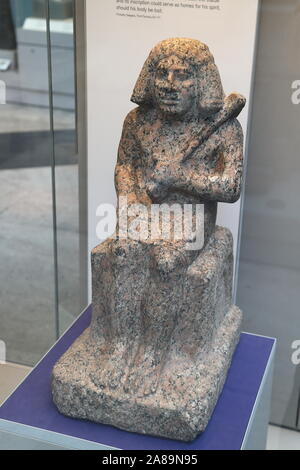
left=125, top=245, right=188, bottom=396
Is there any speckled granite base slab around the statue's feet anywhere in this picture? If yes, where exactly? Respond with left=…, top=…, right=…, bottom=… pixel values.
left=52, top=306, right=242, bottom=441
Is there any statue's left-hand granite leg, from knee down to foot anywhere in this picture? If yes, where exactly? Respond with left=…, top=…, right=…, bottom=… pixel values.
left=91, top=239, right=149, bottom=388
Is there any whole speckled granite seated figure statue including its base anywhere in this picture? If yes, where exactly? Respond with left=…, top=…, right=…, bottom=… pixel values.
left=52, top=38, right=245, bottom=441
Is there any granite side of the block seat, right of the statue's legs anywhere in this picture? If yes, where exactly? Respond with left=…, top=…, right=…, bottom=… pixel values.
left=170, top=227, right=233, bottom=367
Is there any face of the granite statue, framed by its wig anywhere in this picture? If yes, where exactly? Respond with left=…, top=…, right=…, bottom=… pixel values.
left=154, top=55, right=197, bottom=117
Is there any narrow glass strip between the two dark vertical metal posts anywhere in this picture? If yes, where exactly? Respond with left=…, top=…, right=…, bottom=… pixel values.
left=49, top=0, right=86, bottom=334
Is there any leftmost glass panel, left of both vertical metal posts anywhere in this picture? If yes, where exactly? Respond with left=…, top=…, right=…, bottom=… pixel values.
left=0, top=0, right=55, bottom=365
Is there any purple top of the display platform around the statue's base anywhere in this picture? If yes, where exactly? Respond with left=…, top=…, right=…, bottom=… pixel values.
left=0, top=307, right=275, bottom=450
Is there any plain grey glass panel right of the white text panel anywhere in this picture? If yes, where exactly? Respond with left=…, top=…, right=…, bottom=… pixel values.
left=238, top=0, right=300, bottom=428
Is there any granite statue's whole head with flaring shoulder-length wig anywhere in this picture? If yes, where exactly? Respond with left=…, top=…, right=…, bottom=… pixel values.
left=131, top=38, right=224, bottom=118
